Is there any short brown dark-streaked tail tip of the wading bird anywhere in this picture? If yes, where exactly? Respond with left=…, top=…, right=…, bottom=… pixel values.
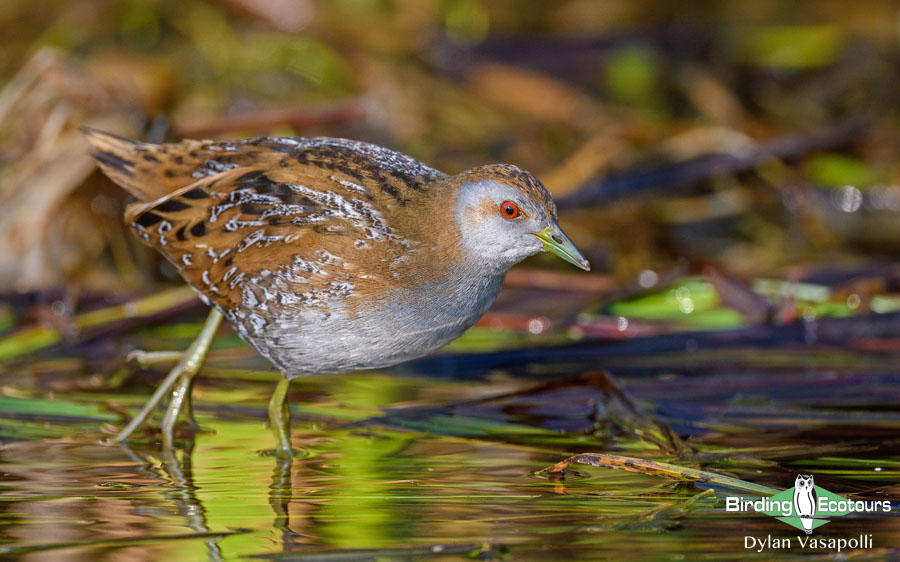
left=81, top=127, right=157, bottom=201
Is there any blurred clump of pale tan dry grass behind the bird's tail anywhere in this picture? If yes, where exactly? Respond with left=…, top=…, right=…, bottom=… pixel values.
left=0, top=49, right=146, bottom=291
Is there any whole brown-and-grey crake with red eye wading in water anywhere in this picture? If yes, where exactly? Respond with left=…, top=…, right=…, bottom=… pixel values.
left=85, top=129, right=589, bottom=456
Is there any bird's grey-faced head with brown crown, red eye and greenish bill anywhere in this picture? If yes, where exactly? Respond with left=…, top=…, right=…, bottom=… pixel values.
left=454, top=164, right=590, bottom=271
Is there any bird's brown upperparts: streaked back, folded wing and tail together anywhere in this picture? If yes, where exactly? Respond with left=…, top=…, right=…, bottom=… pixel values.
left=86, top=130, right=458, bottom=332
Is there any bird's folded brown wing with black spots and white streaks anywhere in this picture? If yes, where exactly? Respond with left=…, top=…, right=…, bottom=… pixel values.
left=126, top=162, right=418, bottom=320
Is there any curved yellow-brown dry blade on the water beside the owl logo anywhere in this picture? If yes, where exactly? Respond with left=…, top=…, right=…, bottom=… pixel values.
left=541, top=453, right=780, bottom=496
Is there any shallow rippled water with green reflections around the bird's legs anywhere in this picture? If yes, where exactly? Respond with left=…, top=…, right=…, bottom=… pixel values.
left=0, top=348, right=900, bottom=561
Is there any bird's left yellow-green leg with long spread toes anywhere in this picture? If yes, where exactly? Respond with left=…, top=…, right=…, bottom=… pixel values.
left=113, top=309, right=222, bottom=442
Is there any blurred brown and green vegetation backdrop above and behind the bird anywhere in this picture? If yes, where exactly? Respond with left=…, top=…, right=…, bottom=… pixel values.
left=0, top=0, right=900, bottom=291
